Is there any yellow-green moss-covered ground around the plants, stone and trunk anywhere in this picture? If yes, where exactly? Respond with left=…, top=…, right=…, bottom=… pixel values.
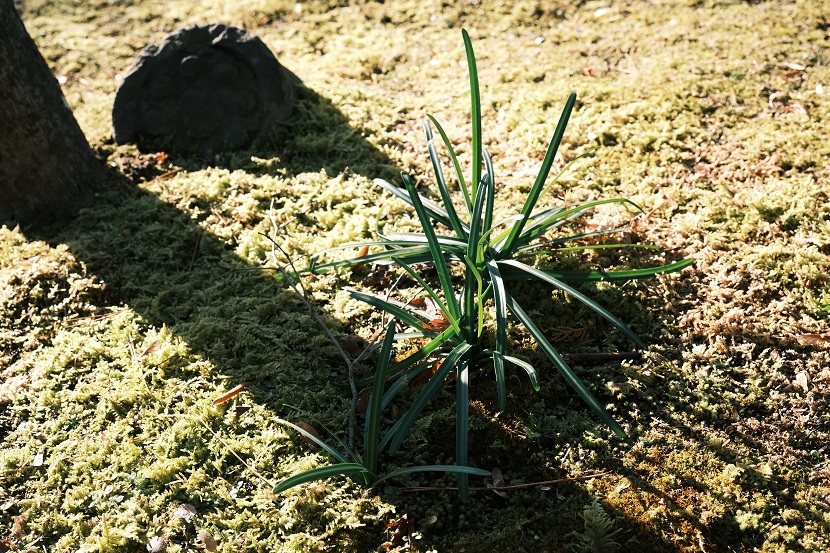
left=0, top=0, right=830, bottom=552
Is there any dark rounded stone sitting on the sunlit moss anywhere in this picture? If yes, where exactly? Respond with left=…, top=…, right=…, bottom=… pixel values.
left=112, top=24, right=300, bottom=155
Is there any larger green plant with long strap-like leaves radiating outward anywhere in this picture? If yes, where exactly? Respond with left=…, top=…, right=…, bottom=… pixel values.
left=310, top=31, right=692, bottom=497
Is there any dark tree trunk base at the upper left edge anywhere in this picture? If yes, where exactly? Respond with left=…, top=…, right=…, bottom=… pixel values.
left=0, top=0, right=105, bottom=226
